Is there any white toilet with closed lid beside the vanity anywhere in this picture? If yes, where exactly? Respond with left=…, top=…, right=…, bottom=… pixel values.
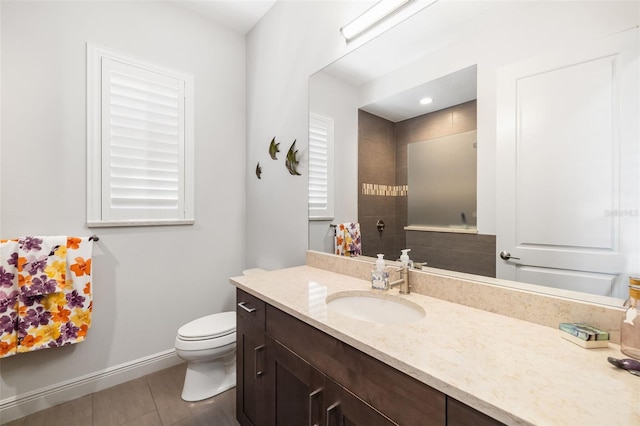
left=175, top=312, right=236, bottom=402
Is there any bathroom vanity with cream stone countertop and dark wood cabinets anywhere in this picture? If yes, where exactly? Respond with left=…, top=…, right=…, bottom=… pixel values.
left=231, top=266, right=640, bottom=425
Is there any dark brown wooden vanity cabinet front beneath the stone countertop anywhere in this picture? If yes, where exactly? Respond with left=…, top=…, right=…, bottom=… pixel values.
left=236, top=289, right=499, bottom=426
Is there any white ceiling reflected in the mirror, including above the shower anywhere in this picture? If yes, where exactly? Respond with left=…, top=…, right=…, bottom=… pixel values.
left=323, top=1, right=495, bottom=122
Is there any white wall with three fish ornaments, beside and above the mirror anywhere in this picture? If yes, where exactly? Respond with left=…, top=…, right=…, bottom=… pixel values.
left=247, top=0, right=371, bottom=269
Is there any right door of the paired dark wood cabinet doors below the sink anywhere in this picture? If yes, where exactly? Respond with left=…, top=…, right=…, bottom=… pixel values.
left=325, top=377, right=396, bottom=426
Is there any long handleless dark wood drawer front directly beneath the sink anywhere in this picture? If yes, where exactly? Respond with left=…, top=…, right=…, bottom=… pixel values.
left=266, top=305, right=446, bottom=426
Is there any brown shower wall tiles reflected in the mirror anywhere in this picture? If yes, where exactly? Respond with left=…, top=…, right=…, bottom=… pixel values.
left=358, top=101, right=480, bottom=276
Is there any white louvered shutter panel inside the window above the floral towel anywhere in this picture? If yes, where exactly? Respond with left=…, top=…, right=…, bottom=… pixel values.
left=102, top=59, right=184, bottom=220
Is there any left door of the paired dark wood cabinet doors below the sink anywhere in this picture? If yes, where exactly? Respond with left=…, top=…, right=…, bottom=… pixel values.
left=265, top=336, right=324, bottom=426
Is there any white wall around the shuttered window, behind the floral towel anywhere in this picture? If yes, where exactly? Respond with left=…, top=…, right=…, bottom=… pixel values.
left=0, top=1, right=246, bottom=420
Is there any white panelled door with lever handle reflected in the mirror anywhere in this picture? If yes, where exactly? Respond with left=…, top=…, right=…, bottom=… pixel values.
left=496, top=29, right=640, bottom=297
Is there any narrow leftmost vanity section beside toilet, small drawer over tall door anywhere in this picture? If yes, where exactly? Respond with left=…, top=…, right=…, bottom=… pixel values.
left=236, top=290, right=266, bottom=426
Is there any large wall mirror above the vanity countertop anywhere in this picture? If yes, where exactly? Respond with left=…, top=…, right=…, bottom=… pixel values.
left=309, top=1, right=640, bottom=305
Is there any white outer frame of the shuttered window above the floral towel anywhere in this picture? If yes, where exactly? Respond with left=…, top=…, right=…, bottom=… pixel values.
left=87, top=42, right=195, bottom=227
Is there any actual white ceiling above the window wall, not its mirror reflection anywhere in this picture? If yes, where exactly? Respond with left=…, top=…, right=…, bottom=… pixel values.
left=168, top=0, right=276, bottom=34
